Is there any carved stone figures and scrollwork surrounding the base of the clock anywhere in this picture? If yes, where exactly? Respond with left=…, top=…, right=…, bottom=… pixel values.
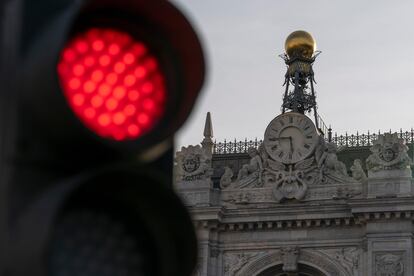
left=220, top=137, right=356, bottom=204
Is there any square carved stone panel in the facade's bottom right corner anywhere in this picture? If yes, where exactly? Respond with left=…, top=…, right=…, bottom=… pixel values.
left=375, top=252, right=404, bottom=276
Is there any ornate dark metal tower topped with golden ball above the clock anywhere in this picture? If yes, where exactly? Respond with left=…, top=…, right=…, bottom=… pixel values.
left=280, top=31, right=321, bottom=130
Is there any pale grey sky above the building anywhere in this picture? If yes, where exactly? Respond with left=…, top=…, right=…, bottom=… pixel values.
left=173, top=0, right=414, bottom=146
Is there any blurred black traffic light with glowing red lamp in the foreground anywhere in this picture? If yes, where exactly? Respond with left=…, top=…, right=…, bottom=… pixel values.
left=8, top=0, right=205, bottom=276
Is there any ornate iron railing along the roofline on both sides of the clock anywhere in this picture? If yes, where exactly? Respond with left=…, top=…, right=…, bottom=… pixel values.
left=213, top=129, right=414, bottom=154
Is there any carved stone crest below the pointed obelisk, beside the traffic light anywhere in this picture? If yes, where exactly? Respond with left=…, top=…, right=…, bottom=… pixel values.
left=174, top=145, right=213, bottom=181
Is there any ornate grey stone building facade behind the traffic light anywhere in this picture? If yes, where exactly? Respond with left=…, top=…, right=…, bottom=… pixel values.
left=175, top=113, right=414, bottom=276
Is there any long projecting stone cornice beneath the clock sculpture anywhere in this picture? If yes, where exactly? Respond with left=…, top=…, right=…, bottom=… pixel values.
left=190, top=198, right=414, bottom=231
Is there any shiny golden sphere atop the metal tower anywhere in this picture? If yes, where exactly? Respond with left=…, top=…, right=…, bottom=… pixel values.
left=285, top=30, right=316, bottom=58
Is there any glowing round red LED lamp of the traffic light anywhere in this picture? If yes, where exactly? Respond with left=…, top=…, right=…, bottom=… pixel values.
left=58, top=28, right=166, bottom=141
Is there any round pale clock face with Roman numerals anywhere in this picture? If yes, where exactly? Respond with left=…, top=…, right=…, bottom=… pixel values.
left=263, top=112, right=319, bottom=164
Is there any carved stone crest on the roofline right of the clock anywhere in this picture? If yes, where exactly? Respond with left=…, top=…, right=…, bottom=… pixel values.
left=366, top=133, right=412, bottom=172
